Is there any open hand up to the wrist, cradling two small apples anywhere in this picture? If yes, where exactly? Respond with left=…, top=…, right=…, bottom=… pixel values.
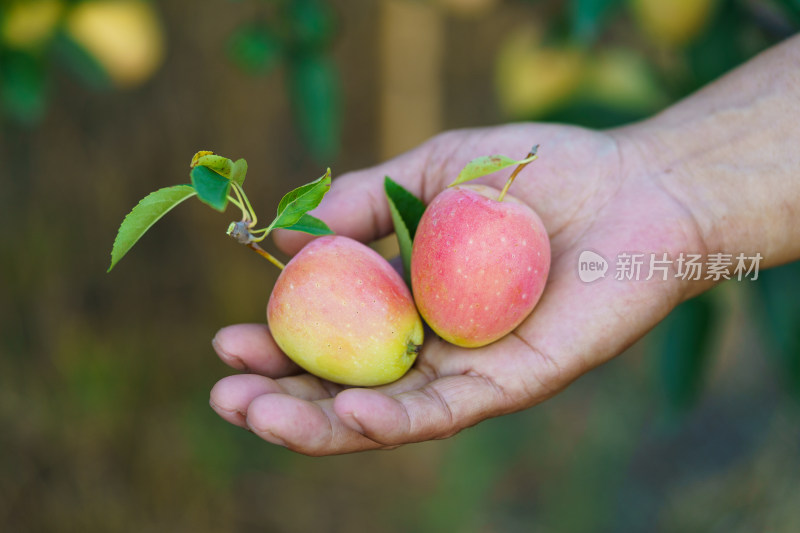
left=211, top=124, right=705, bottom=455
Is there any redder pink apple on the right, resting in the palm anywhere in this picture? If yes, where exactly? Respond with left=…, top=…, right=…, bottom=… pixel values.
left=411, top=185, right=550, bottom=347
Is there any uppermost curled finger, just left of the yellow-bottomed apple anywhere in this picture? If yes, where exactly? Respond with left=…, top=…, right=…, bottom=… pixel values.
left=211, top=324, right=302, bottom=378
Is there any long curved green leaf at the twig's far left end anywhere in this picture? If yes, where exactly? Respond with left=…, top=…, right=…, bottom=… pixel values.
left=108, top=185, right=197, bottom=272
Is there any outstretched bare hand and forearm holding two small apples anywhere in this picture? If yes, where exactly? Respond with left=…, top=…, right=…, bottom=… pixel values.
left=206, top=36, right=800, bottom=455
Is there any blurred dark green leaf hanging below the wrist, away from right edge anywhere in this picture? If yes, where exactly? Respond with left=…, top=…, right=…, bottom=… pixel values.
left=658, top=293, right=716, bottom=414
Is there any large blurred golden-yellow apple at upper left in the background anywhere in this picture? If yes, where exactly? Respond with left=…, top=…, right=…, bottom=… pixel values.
left=66, top=0, right=164, bottom=87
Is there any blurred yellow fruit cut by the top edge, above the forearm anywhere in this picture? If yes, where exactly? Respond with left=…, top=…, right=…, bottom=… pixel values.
left=631, top=0, right=717, bottom=47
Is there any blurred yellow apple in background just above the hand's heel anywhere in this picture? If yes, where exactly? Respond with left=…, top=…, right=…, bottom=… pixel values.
left=495, top=27, right=585, bottom=119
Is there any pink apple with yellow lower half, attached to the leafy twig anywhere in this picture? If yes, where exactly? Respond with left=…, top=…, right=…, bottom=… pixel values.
left=267, top=236, right=423, bottom=386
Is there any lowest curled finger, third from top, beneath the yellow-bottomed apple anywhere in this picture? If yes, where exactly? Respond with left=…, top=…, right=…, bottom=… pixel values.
left=247, top=394, right=390, bottom=456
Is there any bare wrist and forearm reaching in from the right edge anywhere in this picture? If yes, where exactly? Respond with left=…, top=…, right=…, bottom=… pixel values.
left=619, top=59, right=800, bottom=274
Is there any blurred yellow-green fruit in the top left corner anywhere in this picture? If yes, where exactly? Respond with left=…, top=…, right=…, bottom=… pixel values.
left=0, top=0, right=64, bottom=49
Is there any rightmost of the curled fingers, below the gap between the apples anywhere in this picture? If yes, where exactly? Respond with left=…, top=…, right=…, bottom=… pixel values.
left=334, top=375, right=511, bottom=445
